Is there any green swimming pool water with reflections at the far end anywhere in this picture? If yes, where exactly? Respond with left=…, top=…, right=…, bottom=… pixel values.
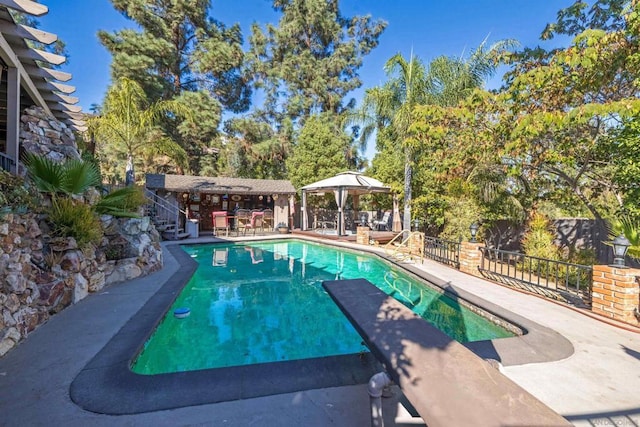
left=132, top=240, right=514, bottom=375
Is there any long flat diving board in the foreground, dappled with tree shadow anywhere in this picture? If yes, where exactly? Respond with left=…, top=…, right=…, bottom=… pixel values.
left=322, top=279, right=570, bottom=427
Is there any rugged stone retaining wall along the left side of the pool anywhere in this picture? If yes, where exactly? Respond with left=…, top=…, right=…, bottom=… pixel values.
left=0, top=213, right=162, bottom=357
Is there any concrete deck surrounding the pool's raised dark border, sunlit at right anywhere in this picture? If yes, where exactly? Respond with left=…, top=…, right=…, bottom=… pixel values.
left=0, top=239, right=640, bottom=426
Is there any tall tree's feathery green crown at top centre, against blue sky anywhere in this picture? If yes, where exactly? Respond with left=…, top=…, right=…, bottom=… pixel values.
left=248, top=0, right=386, bottom=121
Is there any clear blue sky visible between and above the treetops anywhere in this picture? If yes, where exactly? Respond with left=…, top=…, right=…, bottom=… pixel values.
left=40, top=0, right=573, bottom=115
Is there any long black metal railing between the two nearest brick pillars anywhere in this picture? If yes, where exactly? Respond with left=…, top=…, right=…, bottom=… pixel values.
left=478, top=247, right=593, bottom=306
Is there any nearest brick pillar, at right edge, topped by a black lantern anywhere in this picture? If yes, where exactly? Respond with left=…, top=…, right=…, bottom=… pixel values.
left=591, top=265, right=640, bottom=326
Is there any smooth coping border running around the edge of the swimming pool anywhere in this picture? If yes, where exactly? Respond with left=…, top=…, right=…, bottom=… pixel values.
left=70, top=236, right=573, bottom=415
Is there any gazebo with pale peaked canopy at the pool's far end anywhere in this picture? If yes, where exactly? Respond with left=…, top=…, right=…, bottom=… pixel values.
left=302, top=171, right=395, bottom=235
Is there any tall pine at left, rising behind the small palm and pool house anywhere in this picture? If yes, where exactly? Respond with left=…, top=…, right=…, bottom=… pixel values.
left=98, top=0, right=251, bottom=172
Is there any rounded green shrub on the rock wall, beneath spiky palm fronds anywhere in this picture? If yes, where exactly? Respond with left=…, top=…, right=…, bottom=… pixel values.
left=49, top=198, right=102, bottom=248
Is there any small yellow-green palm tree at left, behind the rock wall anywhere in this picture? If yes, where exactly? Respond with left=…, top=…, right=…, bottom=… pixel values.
left=89, top=78, right=189, bottom=185
